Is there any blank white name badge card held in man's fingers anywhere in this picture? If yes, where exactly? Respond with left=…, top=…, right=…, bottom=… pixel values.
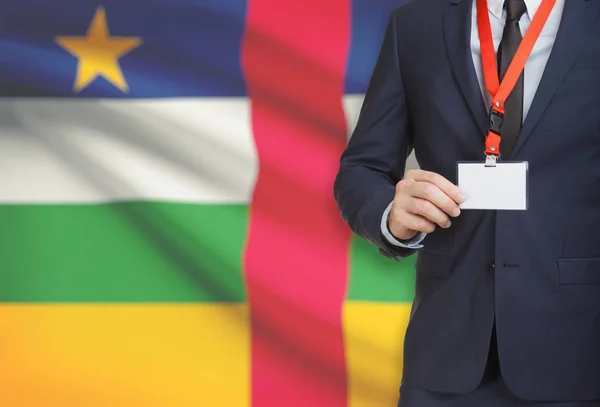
left=458, top=162, right=528, bottom=210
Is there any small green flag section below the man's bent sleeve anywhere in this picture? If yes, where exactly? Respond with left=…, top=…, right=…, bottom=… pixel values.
left=348, top=237, right=415, bottom=302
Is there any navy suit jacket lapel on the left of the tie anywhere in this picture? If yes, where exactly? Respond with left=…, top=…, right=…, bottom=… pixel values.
left=444, top=0, right=488, bottom=135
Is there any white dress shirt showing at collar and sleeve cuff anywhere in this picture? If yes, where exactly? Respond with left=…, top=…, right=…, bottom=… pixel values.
left=381, top=0, right=566, bottom=249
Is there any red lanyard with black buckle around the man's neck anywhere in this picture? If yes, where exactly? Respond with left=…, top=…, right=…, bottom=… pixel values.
left=477, top=0, right=556, bottom=157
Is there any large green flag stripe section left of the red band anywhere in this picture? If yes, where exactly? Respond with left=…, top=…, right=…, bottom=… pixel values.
left=0, top=202, right=248, bottom=302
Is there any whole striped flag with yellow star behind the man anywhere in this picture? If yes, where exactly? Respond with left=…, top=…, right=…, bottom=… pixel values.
left=0, top=0, right=415, bottom=407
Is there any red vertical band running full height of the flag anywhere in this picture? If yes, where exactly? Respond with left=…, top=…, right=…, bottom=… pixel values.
left=243, top=0, right=350, bottom=407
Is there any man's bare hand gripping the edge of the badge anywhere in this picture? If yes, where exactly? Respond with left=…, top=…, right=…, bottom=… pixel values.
left=388, top=170, right=465, bottom=240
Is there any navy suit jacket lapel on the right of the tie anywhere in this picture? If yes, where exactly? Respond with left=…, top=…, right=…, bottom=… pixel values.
left=513, top=0, right=600, bottom=155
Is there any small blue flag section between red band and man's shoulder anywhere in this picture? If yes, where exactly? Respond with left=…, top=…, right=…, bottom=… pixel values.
left=346, top=0, right=406, bottom=93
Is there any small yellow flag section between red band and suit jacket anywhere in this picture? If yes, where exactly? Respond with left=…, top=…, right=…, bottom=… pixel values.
left=343, top=302, right=410, bottom=407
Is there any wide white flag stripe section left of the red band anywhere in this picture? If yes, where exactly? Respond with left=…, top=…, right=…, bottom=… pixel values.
left=0, top=98, right=258, bottom=203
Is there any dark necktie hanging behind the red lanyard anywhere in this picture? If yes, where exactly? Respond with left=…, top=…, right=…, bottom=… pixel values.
left=497, top=0, right=527, bottom=158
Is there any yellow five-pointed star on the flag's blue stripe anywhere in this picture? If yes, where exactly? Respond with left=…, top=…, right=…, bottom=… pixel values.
left=55, top=7, right=142, bottom=92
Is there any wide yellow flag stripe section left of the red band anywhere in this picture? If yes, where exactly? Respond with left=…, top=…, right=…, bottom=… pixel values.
left=0, top=304, right=250, bottom=407
